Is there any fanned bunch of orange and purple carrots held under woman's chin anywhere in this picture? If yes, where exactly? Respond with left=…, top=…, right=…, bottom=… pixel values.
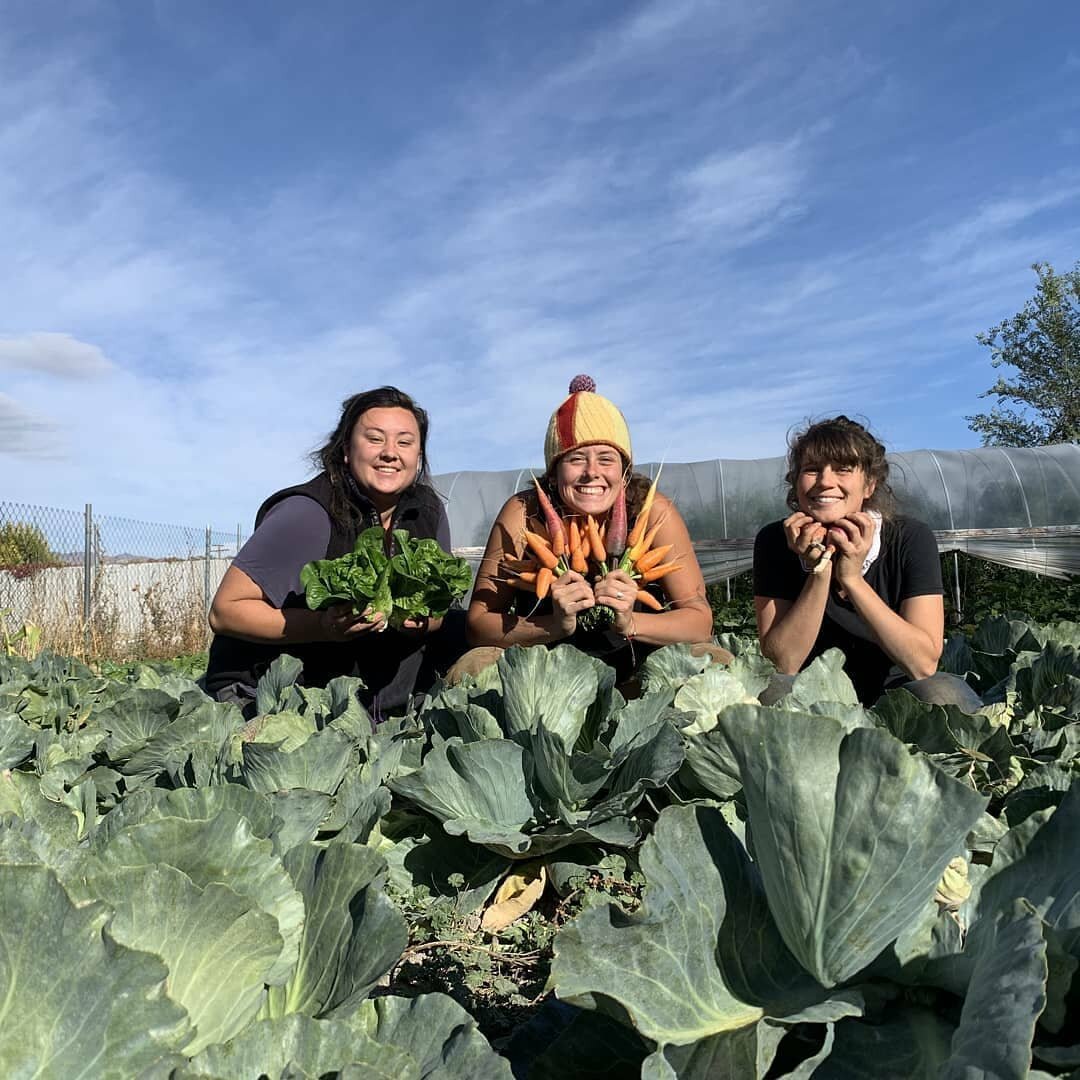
left=502, top=473, right=681, bottom=626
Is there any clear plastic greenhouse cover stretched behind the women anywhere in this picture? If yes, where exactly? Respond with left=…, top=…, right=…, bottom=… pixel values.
left=434, top=444, right=1080, bottom=581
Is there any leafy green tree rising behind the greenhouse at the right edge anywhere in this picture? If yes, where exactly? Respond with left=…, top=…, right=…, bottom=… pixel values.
left=964, top=262, right=1080, bottom=446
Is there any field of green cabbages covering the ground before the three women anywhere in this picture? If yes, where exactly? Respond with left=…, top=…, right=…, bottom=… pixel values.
left=0, top=618, right=1080, bottom=1080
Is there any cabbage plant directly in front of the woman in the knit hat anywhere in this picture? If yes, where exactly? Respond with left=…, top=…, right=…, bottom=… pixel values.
left=390, top=646, right=683, bottom=859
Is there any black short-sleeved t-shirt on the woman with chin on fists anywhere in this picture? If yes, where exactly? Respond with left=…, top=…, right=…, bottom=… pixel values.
left=754, top=517, right=944, bottom=704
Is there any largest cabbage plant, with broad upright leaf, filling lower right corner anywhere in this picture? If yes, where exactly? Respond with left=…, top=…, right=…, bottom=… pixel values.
left=552, top=705, right=1080, bottom=1080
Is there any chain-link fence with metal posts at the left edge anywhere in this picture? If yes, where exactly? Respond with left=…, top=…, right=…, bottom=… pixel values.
left=0, top=502, right=244, bottom=659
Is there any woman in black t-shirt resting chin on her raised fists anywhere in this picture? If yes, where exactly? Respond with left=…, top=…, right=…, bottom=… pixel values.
left=754, top=416, right=982, bottom=711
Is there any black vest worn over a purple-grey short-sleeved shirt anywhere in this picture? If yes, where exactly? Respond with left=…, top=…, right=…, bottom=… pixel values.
left=205, top=473, right=444, bottom=713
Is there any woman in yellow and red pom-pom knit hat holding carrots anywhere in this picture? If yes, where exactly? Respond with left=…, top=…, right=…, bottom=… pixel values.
left=449, top=375, right=730, bottom=683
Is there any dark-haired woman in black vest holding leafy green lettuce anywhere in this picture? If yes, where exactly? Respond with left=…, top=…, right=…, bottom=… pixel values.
left=205, top=387, right=450, bottom=718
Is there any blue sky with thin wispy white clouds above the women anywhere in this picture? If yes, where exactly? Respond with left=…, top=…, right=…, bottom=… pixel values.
left=0, top=0, right=1080, bottom=528
